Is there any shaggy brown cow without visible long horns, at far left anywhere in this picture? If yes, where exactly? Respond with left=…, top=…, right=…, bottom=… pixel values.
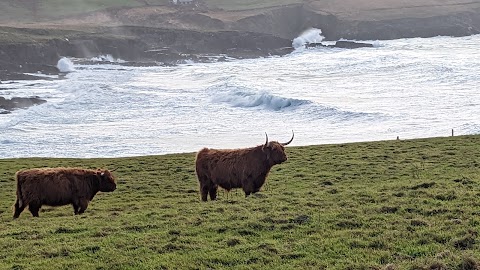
left=13, top=168, right=117, bottom=218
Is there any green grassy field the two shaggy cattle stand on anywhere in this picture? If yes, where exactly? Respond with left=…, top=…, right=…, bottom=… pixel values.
left=0, top=136, right=480, bottom=270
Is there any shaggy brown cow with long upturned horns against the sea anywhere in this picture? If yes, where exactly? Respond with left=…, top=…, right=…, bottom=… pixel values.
left=195, top=133, right=295, bottom=201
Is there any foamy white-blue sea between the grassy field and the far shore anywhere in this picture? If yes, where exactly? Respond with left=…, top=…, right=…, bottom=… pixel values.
left=0, top=33, right=480, bottom=158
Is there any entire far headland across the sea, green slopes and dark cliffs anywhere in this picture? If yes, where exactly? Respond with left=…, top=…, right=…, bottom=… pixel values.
left=0, top=0, right=480, bottom=78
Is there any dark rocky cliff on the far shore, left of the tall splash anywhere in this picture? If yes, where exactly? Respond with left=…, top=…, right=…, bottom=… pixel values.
left=0, top=26, right=291, bottom=80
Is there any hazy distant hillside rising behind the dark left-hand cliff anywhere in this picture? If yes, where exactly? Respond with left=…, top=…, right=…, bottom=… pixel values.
left=0, top=0, right=480, bottom=40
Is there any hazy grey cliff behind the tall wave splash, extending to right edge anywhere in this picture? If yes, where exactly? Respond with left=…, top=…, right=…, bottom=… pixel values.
left=229, top=5, right=480, bottom=40
